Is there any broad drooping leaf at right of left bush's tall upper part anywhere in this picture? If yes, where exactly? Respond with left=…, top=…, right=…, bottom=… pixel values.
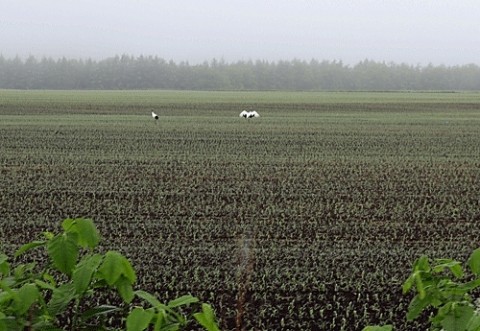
left=98, top=251, right=136, bottom=286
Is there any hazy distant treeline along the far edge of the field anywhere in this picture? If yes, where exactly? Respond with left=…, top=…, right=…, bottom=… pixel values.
left=0, top=55, right=480, bottom=91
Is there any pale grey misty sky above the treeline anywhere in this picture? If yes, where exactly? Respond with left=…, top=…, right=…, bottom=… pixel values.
left=0, top=0, right=480, bottom=65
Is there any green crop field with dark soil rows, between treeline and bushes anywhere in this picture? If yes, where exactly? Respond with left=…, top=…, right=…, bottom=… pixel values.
left=0, top=91, right=480, bottom=330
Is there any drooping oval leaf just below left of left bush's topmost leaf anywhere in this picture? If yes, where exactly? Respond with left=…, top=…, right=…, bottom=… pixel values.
left=47, top=235, right=78, bottom=275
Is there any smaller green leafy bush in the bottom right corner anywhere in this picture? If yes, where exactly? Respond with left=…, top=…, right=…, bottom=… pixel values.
left=364, top=248, right=480, bottom=331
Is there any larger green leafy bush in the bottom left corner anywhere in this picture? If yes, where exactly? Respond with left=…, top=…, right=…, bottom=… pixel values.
left=0, top=219, right=218, bottom=331
